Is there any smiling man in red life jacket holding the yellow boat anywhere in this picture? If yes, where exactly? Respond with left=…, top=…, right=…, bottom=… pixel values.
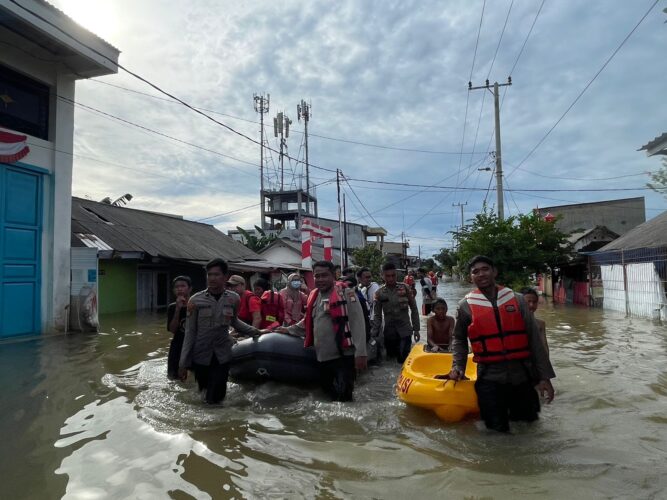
left=449, top=255, right=556, bottom=432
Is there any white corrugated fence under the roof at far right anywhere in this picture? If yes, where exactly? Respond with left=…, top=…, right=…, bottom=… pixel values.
left=590, top=247, right=667, bottom=321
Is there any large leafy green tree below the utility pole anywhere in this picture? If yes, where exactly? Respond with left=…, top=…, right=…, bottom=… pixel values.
left=455, top=207, right=570, bottom=288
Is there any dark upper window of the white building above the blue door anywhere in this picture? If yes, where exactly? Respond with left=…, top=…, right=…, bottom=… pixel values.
left=0, top=65, right=49, bottom=140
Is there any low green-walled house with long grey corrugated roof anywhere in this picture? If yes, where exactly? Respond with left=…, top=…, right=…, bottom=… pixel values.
left=71, top=198, right=290, bottom=318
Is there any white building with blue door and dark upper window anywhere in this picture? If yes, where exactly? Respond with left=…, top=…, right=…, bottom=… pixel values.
left=0, top=0, right=119, bottom=339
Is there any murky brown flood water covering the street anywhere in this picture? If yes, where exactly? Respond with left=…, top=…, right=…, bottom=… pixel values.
left=0, top=284, right=667, bottom=499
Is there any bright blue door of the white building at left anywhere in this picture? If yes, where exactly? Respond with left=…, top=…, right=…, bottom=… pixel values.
left=0, top=165, right=42, bottom=338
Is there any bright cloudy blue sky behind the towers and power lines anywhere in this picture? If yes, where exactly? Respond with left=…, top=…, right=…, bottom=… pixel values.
left=51, top=0, right=667, bottom=255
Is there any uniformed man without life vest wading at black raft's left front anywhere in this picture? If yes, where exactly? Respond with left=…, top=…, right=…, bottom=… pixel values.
left=179, top=259, right=263, bottom=404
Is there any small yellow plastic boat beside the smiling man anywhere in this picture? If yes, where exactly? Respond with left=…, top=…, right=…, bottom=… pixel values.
left=396, top=344, right=479, bottom=422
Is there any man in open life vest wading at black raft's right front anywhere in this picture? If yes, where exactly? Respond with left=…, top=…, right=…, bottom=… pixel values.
left=276, top=261, right=366, bottom=401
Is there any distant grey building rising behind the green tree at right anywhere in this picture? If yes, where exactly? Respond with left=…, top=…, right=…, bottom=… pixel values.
left=535, top=196, right=646, bottom=235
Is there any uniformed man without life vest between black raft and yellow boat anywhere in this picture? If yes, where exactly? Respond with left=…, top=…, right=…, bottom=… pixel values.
left=371, top=262, right=419, bottom=363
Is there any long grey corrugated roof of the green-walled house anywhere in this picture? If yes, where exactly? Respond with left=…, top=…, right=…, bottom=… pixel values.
left=72, top=198, right=266, bottom=262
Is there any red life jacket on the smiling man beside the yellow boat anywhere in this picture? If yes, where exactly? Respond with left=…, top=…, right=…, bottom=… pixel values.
left=465, top=287, right=530, bottom=363
